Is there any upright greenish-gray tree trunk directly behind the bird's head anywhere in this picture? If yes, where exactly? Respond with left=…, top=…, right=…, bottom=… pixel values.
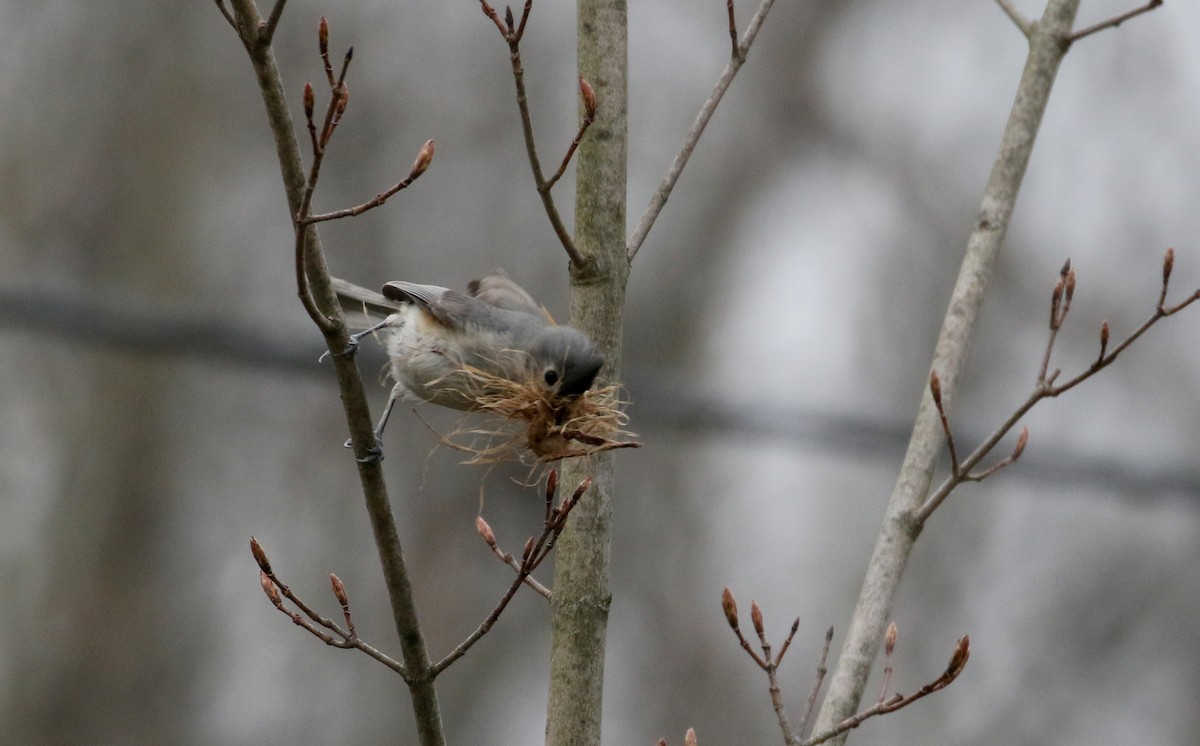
left=546, top=0, right=629, bottom=746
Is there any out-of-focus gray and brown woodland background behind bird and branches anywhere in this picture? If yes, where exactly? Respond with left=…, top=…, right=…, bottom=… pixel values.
left=0, top=0, right=1200, bottom=745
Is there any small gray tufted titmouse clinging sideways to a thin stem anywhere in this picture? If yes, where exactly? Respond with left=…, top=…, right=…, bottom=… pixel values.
left=334, top=270, right=604, bottom=441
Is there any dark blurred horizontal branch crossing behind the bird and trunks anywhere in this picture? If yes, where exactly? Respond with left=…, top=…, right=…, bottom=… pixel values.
left=0, top=287, right=1200, bottom=506
